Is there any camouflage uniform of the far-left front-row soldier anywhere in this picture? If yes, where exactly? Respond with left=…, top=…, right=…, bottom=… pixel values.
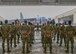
left=1, top=24, right=10, bottom=52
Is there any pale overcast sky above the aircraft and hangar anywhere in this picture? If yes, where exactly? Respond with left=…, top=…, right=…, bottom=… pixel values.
left=0, top=6, right=76, bottom=19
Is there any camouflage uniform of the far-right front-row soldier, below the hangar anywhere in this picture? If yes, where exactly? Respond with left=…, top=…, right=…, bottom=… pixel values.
left=66, top=25, right=75, bottom=53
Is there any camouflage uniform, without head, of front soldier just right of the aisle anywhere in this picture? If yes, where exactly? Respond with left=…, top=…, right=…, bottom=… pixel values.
left=44, top=24, right=53, bottom=53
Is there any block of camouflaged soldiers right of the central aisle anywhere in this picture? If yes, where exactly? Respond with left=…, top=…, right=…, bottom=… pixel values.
left=41, top=22, right=76, bottom=53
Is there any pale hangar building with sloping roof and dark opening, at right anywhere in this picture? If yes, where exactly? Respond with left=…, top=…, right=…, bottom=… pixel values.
left=55, top=9, right=76, bottom=25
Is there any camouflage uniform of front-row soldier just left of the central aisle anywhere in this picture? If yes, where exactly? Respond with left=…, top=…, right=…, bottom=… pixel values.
left=21, top=25, right=31, bottom=53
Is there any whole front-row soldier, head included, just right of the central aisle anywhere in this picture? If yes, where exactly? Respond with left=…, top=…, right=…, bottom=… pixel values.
left=42, top=22, right=53, bottom=53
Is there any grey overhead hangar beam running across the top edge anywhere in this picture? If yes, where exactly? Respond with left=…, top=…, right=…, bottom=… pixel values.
left=0, top=0, right=76, bottom=5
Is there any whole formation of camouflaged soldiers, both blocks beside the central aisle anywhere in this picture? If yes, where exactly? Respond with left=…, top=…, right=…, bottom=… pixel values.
left=0, top=19, right=76, bottom=54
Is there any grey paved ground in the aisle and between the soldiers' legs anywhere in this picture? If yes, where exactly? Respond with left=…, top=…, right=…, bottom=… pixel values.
left=0, top=31, right=76, bottom=54
